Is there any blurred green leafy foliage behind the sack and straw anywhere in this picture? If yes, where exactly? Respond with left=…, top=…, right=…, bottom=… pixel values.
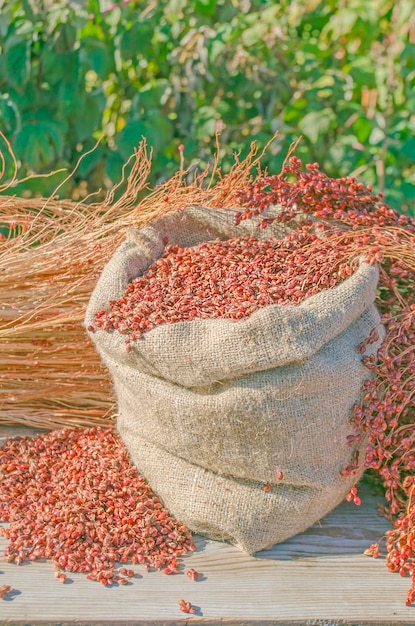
left=0, top=0, right=415, bottom=214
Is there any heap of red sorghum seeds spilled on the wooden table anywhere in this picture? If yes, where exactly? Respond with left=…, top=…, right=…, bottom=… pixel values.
left=0, top=428, right=195, bottom=585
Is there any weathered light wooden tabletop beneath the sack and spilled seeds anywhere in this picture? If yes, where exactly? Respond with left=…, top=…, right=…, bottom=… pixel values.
left=0, top=428, right=415, bottom=626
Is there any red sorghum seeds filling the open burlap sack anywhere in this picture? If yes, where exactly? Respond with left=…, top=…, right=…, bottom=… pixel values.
left=89, top=231, right=357, bottom=343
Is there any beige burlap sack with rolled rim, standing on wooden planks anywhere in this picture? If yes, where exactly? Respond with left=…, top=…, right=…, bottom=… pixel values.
left=85, top=207, right=382, bottom=553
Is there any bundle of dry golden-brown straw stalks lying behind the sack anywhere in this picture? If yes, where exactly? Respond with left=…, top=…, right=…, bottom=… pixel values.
left=0, top=141, right=263, bottom=429
